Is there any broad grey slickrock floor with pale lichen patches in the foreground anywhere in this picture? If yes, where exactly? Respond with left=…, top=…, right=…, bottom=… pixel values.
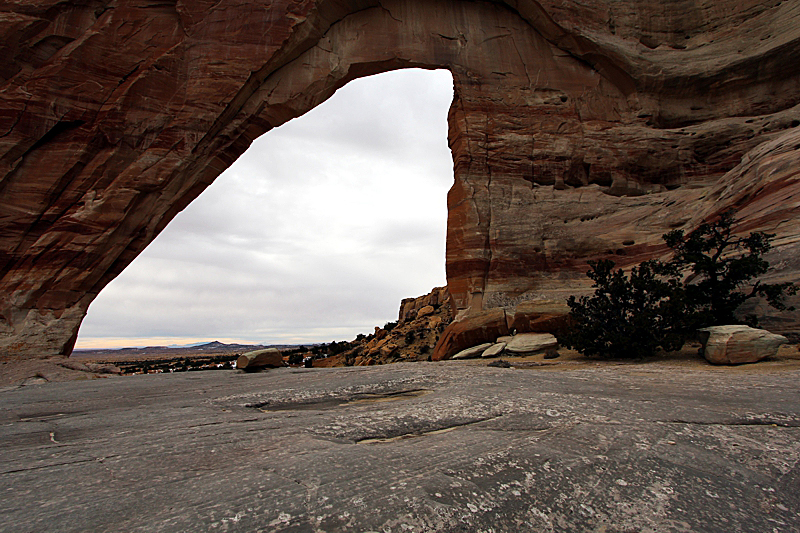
left=0, top=361, right=800, bottom=533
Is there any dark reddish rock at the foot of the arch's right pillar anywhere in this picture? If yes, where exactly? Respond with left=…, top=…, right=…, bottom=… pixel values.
left=432, top=309, right=508, bottom=361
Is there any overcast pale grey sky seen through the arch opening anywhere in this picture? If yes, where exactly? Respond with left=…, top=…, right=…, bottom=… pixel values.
left=77, top=69, right=460, bottom=348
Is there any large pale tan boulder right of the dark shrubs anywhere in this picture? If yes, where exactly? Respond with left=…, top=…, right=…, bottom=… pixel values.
left=699, top=325, right=788, bottom=365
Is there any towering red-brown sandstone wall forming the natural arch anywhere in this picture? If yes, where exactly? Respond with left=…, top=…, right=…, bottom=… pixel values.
left=0, top=0, right=800, bottom=356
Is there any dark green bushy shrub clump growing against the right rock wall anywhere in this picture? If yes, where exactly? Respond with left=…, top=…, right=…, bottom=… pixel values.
left=561, top=212, right=797, bottom=358
